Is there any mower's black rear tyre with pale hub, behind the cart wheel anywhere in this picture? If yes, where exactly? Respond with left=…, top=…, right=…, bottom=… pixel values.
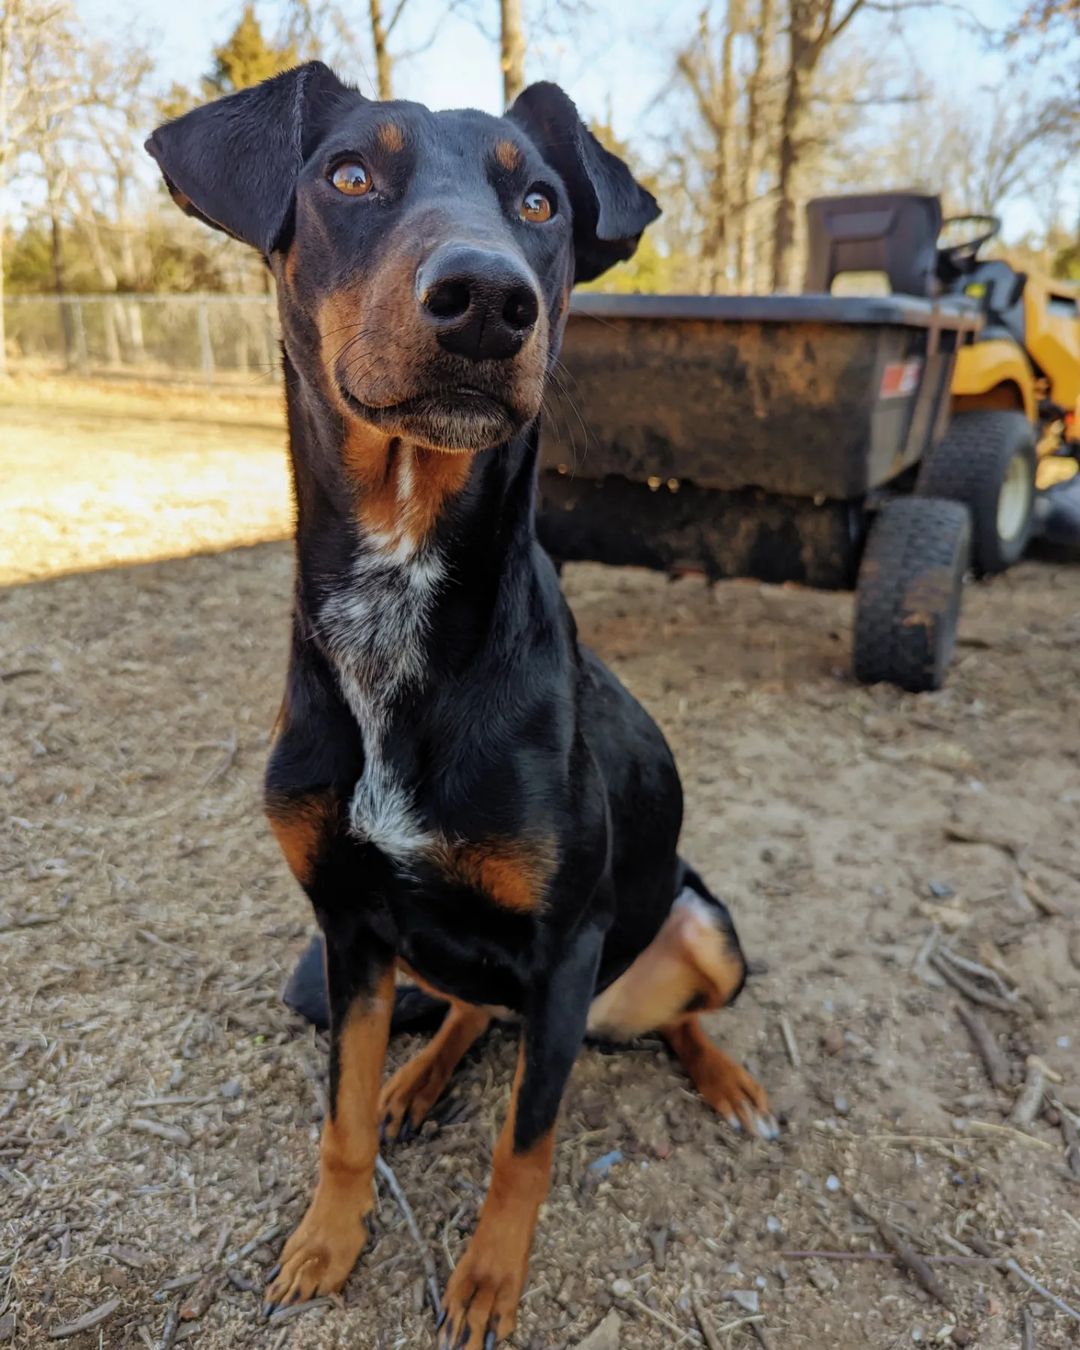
left=915, top=410, right=1035, bottom=576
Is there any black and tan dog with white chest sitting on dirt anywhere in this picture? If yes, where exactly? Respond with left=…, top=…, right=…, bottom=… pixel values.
left=147, top=63, right=775, bottom=1350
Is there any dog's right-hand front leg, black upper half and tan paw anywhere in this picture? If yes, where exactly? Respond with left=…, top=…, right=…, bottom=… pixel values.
left=439, top=927, right=602, bottom=1350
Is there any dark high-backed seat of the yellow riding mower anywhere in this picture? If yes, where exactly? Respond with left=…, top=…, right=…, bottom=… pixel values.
left=803, top=192, right=941, bottom=298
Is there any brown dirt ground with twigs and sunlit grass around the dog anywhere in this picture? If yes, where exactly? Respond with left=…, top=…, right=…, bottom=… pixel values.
left=0, top=380, right=1080, bottom=1350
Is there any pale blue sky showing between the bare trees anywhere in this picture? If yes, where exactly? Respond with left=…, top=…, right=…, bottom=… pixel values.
left=76, top=0, right=1080, bottom=235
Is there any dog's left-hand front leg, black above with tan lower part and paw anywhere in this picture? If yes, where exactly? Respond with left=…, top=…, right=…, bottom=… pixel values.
left=266, top=913, right=394, bottom=1312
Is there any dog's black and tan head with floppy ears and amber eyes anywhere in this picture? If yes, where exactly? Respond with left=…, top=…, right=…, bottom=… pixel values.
left=147, top=62, right=659, bottom=451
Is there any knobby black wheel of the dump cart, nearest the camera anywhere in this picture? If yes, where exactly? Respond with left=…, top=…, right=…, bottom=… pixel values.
left=855, top=497, right=971, bottom=694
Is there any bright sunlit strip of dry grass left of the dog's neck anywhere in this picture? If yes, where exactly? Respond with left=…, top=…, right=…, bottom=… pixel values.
left=0, top=377, right=290, bottom=585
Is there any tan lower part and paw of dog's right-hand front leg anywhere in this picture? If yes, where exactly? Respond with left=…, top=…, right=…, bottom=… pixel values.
left=439, top=1050, right=555, bottom=1350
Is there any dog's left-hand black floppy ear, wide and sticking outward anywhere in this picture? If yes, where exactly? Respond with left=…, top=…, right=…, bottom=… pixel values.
left=146, top=61, right=353, bottom=254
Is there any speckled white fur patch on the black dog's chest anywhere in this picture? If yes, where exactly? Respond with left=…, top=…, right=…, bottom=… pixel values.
left=320, top=536, right=446, bottom=860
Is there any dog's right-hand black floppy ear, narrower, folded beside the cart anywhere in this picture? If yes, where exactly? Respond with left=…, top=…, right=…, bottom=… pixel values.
left=506, top=82, right=660, bottom=281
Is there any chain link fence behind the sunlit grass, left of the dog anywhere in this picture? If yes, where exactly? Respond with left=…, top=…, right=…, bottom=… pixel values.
left=4, top=294, right=281, bottom=386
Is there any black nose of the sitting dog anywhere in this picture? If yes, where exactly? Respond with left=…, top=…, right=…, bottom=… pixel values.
left=416, top=244, right=540, bottom=360
